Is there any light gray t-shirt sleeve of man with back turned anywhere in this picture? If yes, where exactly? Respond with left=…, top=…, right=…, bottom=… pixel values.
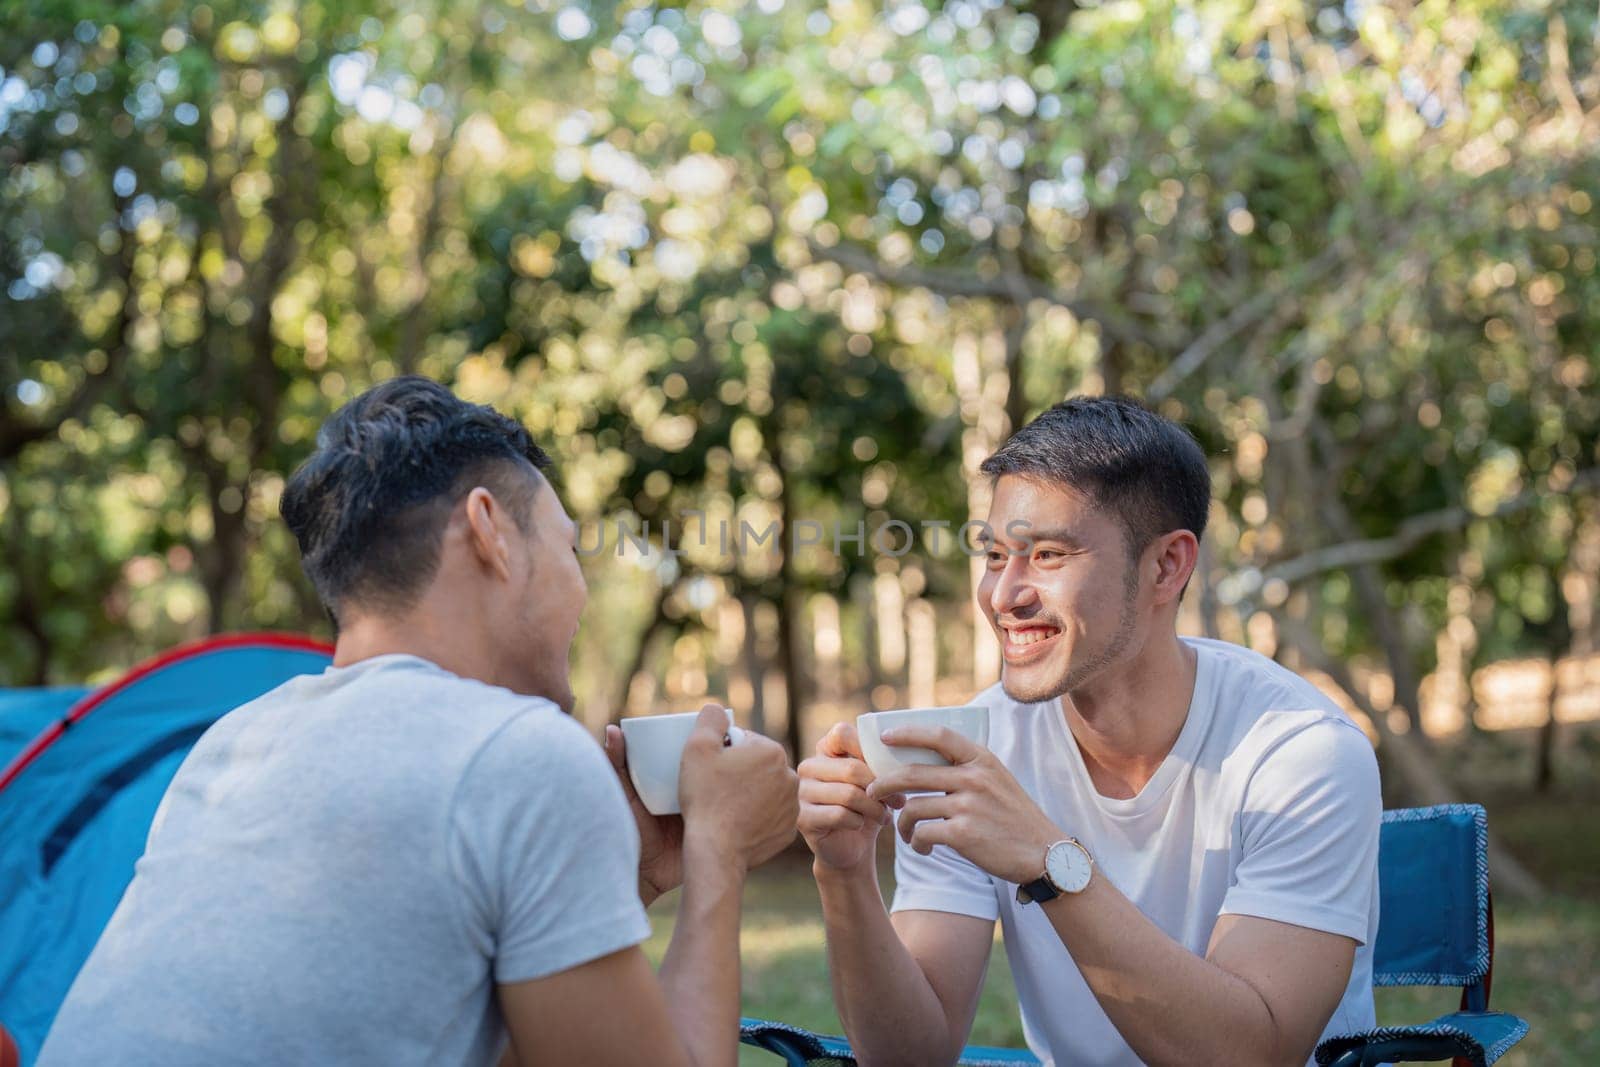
left=451, top=705, right=650, bottom=982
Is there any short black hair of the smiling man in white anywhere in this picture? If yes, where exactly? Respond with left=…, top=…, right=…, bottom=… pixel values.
left=979, top=397, right=1211, bottom=555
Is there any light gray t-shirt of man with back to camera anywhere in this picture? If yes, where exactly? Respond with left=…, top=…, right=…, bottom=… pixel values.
left=37, top=656, right=650, bottom=1067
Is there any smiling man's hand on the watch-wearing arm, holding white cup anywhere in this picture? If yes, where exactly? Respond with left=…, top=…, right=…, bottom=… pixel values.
left=867, top=726, right=1067, bottom=885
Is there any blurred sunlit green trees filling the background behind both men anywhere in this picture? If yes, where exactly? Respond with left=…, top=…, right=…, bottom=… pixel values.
left=0, top=0, right=1600, bottom=883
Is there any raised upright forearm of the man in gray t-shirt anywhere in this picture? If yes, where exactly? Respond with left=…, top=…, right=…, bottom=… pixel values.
left=661, top=840, right=746, bottom=1067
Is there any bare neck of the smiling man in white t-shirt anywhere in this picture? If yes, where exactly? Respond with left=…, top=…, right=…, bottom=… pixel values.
left=1061, top=630, right=1197, bottom=798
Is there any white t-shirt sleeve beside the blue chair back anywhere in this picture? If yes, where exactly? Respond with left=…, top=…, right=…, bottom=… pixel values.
left=1221, top=718, right=1382, bottom=944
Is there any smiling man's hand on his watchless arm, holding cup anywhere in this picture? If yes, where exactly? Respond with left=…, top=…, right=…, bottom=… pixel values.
left=800, top=723, right=904, bottom=870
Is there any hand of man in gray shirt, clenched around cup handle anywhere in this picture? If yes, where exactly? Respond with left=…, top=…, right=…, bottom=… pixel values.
left=678, top=704, right=798, bottom=870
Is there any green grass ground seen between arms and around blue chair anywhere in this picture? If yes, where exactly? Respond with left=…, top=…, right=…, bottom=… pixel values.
left=646, top=844, right=1600, bottom=1067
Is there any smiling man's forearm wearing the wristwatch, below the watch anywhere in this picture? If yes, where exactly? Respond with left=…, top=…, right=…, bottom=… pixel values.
left=1042, top=877, right=1306, bottom=1065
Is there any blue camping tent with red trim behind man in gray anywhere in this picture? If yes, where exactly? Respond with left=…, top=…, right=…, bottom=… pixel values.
left=0, top=633, right=331, bottom=1064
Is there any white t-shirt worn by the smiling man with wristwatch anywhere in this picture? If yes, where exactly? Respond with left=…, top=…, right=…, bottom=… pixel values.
left=893, top=640, right=1382, bottom=1065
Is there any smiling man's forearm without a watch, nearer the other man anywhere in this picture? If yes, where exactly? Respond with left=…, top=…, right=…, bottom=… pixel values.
left=814, top=859, right=962, bottom=1064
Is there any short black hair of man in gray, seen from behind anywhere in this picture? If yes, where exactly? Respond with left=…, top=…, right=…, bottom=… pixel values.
left=282, top=374, right=550, bottom=622
